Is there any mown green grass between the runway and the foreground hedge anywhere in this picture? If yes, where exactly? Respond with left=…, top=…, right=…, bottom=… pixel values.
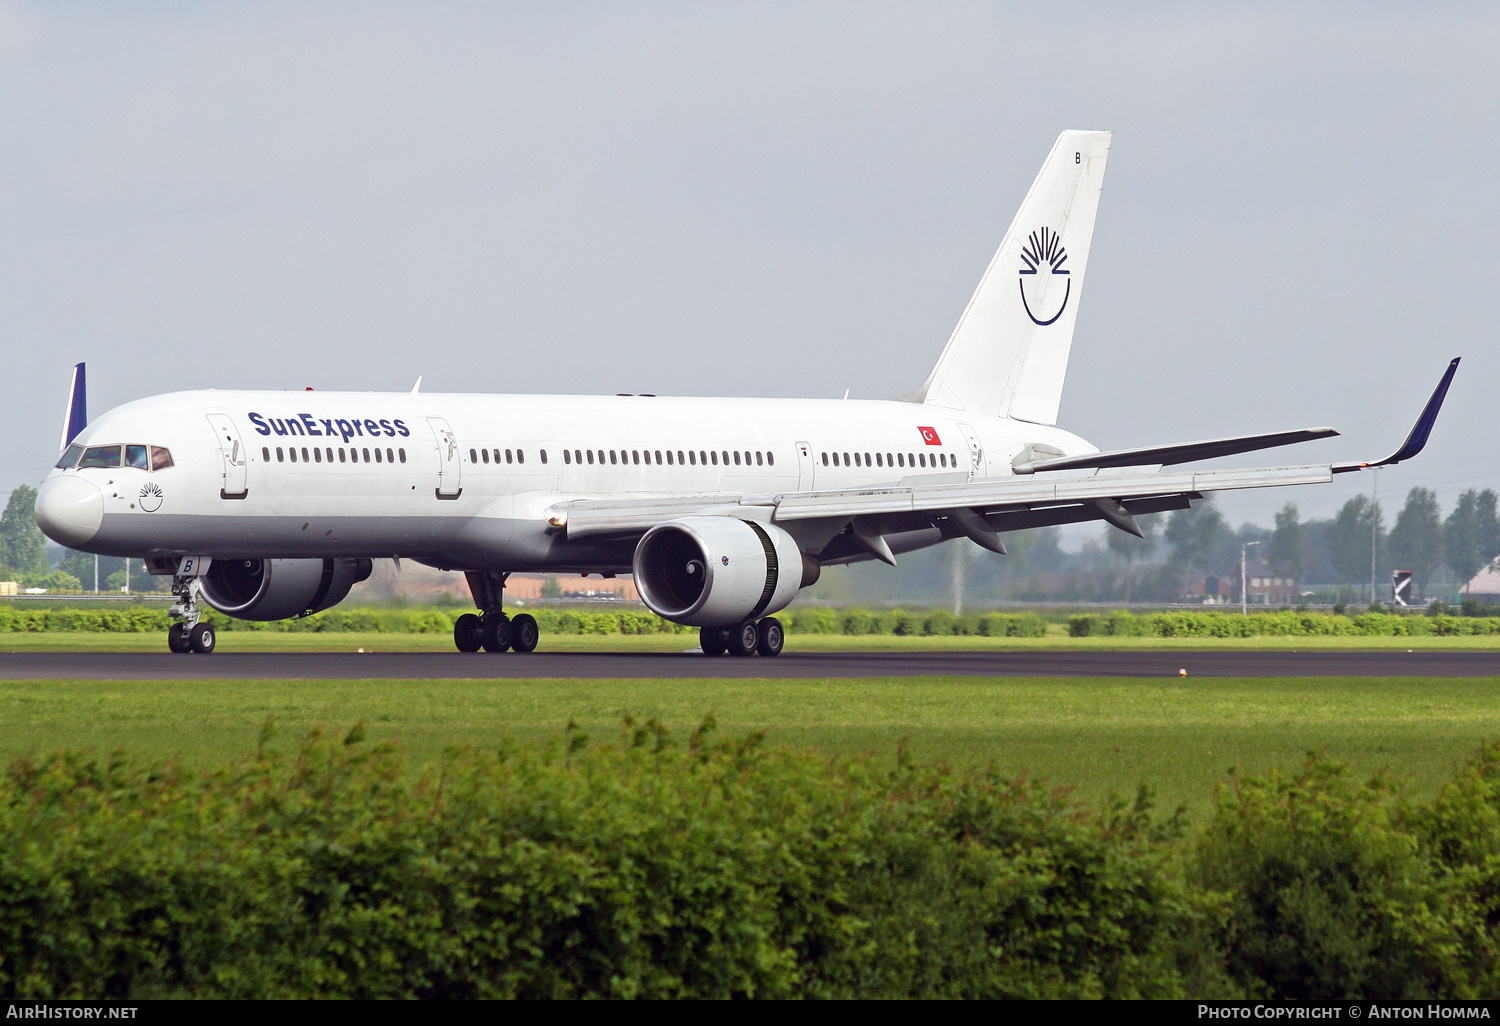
left=0, top=678, right=1500, bottom=815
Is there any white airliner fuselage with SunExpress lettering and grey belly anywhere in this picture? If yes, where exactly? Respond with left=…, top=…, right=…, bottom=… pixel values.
left=38, top=390, right=1094, bottom=572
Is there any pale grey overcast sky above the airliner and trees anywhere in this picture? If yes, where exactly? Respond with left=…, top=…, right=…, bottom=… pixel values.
left=0, top=0, right=1500, bottom=537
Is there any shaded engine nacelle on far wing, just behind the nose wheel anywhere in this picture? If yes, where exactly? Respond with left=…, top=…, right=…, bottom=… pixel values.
left=203, top=560, right=371, bottom=620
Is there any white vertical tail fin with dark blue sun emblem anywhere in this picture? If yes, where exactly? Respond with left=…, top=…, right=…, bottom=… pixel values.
left=903, top=132, right=1110, bottom=425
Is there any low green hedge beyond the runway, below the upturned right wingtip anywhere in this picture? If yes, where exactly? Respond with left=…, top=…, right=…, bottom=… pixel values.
left=1068, top=611, right=1500, bottom=638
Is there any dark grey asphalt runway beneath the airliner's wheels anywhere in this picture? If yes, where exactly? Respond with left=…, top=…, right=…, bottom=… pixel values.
left=0, top=650, right=1500, bottom=681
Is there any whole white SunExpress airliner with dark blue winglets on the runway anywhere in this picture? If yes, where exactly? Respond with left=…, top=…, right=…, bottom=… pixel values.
left=36, top=132, right=1458, bottom=656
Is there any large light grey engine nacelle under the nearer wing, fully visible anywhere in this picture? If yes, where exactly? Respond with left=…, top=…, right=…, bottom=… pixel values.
left=632, top=516, right=818, bottom=627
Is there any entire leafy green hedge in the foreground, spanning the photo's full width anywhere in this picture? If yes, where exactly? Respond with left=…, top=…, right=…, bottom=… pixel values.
left=14, top=717, right=1500, bottom=1001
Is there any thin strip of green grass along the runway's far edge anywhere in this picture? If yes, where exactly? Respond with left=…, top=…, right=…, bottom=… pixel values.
left=0, top=630, right=1500, bottom=653
